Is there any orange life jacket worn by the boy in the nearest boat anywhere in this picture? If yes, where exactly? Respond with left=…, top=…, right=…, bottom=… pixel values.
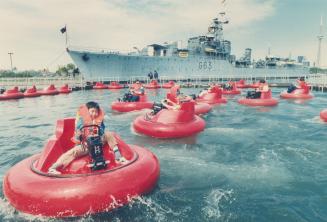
left=72, top=105, right=104, bottom=144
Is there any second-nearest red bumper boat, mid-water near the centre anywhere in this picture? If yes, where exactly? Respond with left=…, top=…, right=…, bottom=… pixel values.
left=133, top=101, right=205, bottom=138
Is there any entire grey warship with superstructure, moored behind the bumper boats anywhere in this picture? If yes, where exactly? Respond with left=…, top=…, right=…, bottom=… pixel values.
left=67, top=12, right=309, bottom=80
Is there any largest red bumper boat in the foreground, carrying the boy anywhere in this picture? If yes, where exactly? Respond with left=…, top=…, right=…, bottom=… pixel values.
left=3, top=118, right=160, bottom=217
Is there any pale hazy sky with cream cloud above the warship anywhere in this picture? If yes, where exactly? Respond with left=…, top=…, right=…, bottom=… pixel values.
left=0, top=0, right=327, bottom=71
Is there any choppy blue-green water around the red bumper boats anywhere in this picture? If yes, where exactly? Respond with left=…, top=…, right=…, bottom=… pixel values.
left=0, top=89, right=327, bottom=222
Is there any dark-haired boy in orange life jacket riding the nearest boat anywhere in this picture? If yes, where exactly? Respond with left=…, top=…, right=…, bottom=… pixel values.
left=48, top=101, right=126, bottom=174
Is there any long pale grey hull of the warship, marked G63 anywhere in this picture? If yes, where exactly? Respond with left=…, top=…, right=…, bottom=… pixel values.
left=67, top=50, right=309, bottom=80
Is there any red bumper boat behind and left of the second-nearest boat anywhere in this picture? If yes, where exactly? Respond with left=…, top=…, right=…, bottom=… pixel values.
left=111, top=94, right=153, bottom=112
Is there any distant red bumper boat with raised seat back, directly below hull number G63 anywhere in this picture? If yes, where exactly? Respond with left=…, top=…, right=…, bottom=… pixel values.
left=195, top=85, right=227, bottom=105
